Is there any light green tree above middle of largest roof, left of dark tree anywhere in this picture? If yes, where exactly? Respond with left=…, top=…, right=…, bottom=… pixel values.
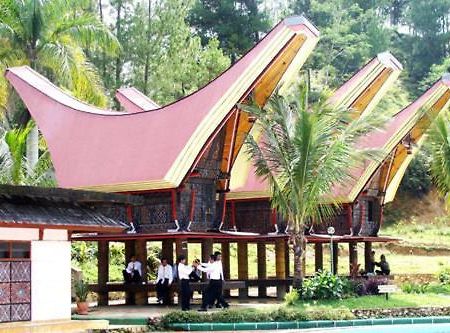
left=125, top=0, right=230, bottom=104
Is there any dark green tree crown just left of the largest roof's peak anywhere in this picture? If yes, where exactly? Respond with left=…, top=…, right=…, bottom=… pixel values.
left=189, top=0, right=269, bottom=62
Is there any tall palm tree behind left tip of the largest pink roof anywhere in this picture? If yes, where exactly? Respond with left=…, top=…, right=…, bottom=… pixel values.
left=0, top=0, right=119, bottom=165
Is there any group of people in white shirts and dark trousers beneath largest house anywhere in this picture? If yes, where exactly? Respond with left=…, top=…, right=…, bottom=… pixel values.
left=123, top=251, right=229, bottom=311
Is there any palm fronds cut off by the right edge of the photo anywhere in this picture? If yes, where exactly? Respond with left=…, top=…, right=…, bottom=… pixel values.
left=429, top=114, right=450, bottom=207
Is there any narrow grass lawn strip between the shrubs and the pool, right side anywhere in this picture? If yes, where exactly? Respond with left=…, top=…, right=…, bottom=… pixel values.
left=296, top=293, right=450, bottom=310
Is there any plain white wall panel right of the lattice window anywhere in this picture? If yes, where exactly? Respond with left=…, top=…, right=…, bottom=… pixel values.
left=31, top=240, right=71, bottom=320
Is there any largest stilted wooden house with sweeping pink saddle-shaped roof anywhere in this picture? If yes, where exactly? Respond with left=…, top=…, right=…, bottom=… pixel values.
left=6, top=17, right=319, bottom=304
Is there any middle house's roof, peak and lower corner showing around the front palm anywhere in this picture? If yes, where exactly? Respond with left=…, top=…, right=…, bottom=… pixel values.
left=227, top=52, right=403, bottom=200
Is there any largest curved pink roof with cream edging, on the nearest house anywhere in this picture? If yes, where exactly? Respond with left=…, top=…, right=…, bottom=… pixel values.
left=6, top=16, right=319, bottom=192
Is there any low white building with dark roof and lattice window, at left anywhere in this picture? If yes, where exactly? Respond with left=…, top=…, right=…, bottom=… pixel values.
left=0, top=185, right=133, bottom=326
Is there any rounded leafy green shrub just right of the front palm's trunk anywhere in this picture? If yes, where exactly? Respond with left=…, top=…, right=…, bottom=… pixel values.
left=302, top=271, right=348, bottom=299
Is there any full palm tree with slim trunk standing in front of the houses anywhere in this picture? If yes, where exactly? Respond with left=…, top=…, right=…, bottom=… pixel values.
left=241, top=85, right=385, bottom=289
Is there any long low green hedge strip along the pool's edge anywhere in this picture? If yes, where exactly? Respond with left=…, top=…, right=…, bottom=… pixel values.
left=159, top=307, right=355, bottom=328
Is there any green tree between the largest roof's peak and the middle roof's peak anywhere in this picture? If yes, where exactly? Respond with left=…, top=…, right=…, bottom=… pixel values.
left=291, top=0, right=391, bottom=87
